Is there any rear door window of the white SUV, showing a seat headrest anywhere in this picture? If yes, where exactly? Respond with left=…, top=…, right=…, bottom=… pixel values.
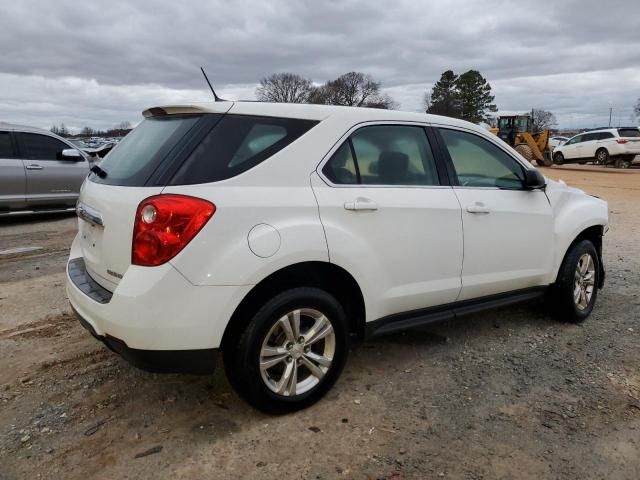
left=351, top=125, right=439, bottom=185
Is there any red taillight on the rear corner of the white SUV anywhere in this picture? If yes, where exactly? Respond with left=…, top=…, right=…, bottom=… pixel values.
left=131, top=194, right=216, bottom=267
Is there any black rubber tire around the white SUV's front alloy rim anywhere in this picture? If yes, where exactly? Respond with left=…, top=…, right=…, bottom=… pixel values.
left=547, top=240, right=600, bottom=323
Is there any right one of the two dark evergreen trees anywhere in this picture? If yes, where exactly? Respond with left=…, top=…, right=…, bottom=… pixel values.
left=456, top=70, right=497, bottom=123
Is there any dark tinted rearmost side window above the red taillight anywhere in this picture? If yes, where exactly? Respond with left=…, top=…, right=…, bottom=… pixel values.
left=171, top=114, right=318, bottom=185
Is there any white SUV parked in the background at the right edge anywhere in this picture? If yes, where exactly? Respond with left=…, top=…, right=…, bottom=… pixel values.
left=553, top=127, right=640, bottom=168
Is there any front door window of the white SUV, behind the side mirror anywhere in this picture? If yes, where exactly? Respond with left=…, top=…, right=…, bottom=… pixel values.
left=440, top=128, right=524, bottom=188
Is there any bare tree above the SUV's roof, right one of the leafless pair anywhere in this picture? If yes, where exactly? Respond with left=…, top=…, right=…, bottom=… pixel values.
left=309, top=72, right=395, bottom=109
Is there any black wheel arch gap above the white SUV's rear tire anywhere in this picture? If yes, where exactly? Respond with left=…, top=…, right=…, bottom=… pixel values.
left=221, top=261, right=366, bottom=352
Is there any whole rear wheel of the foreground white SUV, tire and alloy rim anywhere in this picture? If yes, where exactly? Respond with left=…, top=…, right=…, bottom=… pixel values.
left=223, top=287, right=349, bottom=413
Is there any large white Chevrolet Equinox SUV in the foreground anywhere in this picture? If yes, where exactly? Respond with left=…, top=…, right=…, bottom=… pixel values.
left=67, top=102, right=608, bottom=413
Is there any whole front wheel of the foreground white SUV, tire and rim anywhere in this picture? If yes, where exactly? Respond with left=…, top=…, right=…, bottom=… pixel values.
left=548, top=240, right=600, bottom=323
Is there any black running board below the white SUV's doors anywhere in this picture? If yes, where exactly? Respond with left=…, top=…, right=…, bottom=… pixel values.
left=366, top=287, right=546, bottom=338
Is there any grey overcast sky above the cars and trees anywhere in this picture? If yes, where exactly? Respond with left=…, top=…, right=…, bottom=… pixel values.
left=0, top=0, right=640, bottom=129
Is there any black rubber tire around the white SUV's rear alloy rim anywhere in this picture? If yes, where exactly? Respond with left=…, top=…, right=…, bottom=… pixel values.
left=223, top=287, right=349, bottom=414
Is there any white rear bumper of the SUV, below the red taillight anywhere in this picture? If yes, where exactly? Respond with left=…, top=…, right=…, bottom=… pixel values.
left=66, top=234, right=251, bottom=350
